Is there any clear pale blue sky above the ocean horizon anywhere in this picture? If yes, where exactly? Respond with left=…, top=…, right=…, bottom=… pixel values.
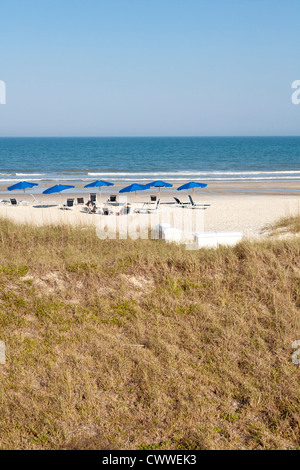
left=0, top=0, right=300, bottom=136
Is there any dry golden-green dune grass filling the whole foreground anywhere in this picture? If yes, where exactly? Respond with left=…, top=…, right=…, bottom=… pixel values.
left=0, top=220, right=300, bottom=450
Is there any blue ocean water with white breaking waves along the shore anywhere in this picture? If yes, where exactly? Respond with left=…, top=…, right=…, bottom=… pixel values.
left=0, top=137, right=300, bottom=184
